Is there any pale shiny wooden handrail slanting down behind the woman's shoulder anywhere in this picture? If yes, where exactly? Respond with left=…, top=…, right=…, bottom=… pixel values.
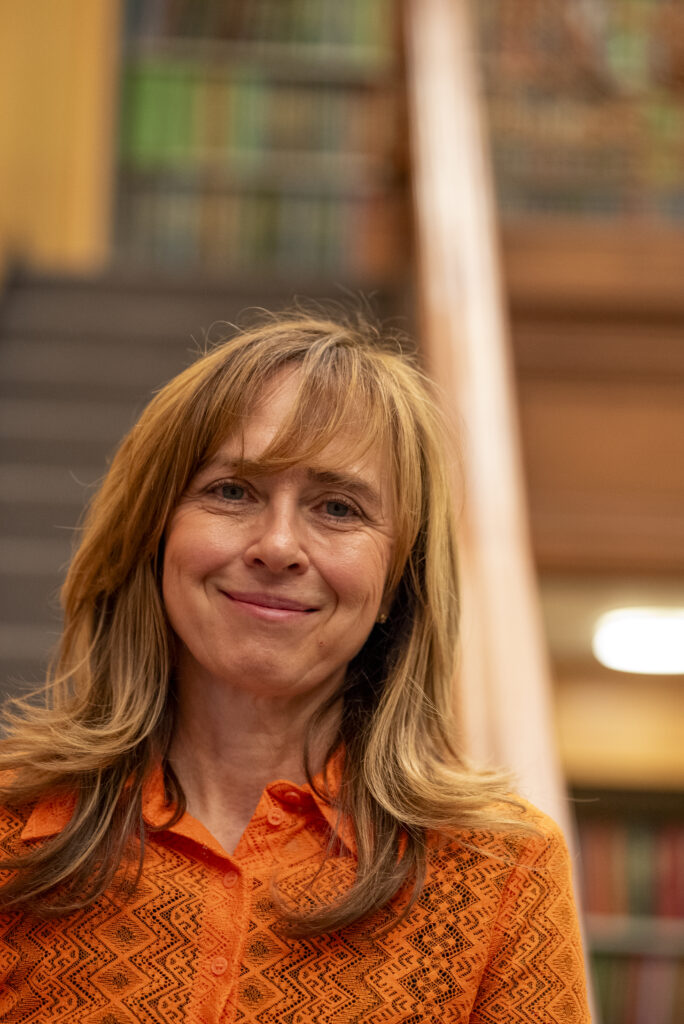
left=405, top=0, right=571, bottom=840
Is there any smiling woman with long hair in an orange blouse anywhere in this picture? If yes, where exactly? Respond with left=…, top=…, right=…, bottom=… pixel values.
left=0, top=316, right=589, bottom=1024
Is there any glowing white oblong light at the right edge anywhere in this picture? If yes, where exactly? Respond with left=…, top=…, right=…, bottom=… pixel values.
left=592, top=608, right=684, bottom=676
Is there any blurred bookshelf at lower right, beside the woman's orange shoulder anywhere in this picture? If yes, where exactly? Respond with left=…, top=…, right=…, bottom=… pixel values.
left=574, top=788, right=684, bottom=1024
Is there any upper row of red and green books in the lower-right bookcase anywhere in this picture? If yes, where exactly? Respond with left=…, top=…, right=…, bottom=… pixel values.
left=579, top=817, right=684, bottom=919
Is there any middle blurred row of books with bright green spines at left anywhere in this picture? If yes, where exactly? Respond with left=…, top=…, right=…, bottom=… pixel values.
left=120, top=57, right=396, bottom=167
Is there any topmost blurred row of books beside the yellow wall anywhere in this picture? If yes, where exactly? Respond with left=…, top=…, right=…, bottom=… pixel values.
left=126, top=0, right=394, bottom=50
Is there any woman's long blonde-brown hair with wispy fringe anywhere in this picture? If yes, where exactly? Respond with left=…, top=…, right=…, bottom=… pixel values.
left=0, top=313, right=524, bottom=934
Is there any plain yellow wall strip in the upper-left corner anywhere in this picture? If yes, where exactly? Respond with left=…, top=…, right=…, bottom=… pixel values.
left=0, top=0, right=120, bottom=270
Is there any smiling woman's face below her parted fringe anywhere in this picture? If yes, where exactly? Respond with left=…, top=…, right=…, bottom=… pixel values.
left=163, top=371, right=393, bottom=697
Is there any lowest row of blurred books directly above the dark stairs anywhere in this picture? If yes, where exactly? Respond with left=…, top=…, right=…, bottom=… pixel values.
left=117, top=185, right=402, bottom=276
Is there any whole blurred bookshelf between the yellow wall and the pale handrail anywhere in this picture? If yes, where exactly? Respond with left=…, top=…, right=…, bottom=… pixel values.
left=114, top=0, right=408, bottom=289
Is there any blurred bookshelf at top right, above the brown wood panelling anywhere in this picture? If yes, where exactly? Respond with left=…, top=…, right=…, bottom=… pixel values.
left=472, top=0, right=684, bottom=224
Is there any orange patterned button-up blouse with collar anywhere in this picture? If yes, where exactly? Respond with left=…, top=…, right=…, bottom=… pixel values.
left=0, top=769, right=590, bottom=1024
